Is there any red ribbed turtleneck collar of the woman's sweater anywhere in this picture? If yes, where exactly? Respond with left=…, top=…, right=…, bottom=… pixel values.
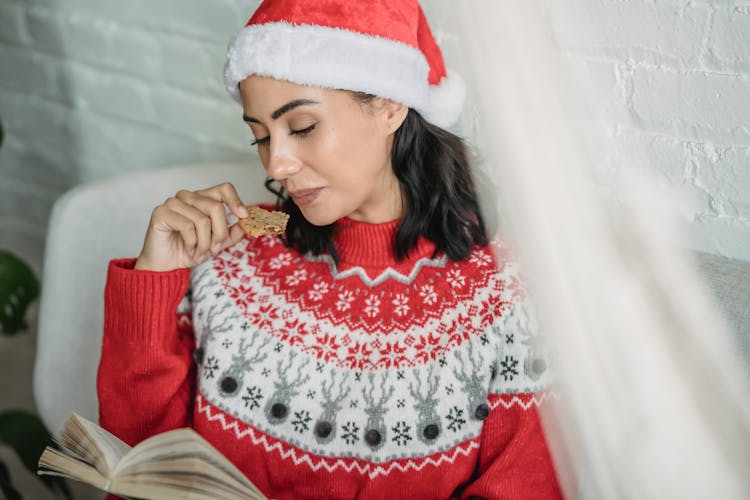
left=333, top=217, right=435, bottom=267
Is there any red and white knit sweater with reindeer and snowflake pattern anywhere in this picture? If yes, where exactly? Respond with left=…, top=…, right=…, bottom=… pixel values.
left=98, top=219, right=562, bottom=500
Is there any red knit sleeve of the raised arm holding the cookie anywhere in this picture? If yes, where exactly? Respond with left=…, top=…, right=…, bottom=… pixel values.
left=97, top=259, right=195, bottom=446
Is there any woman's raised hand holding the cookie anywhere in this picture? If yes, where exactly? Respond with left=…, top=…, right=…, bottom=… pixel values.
left=135, top=182, right=247, bottom=271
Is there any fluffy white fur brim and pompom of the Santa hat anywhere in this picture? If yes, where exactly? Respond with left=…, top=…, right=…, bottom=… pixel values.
left=224, top=22, right=463, bottom=126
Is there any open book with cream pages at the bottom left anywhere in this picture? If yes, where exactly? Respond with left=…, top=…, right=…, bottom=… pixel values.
left=38, top=413, right=265, bottom=500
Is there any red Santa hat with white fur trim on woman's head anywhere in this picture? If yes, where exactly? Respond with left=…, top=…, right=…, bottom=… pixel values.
left=224, top=0, right=465, bottom=127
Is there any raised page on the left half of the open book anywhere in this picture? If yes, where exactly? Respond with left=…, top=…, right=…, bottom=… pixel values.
left=59, top=413, right=130, bottom=477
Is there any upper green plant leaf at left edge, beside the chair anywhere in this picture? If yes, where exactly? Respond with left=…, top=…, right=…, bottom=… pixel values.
left=0, top=250, right=39, bottom=335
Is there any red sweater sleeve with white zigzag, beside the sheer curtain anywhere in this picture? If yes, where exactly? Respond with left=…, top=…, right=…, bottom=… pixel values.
left=461, top=394, right=563, bottom=500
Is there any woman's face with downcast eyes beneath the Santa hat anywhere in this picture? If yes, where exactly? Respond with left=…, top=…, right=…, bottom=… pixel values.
left=240, top=75, right=408, bottom=226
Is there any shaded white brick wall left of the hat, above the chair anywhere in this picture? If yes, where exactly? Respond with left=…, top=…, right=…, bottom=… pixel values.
left=0, top=0, right=258, bottom=278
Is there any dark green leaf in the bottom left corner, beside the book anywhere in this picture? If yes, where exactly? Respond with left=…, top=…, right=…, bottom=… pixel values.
left=0, top=410, right=73, bottom=499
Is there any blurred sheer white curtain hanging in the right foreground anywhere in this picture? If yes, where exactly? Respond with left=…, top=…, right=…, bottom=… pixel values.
left=425, top=0, right=750, bottom=500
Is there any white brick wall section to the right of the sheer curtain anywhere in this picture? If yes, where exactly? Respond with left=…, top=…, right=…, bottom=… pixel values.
left=545, top=0, right=750, bottom=259
